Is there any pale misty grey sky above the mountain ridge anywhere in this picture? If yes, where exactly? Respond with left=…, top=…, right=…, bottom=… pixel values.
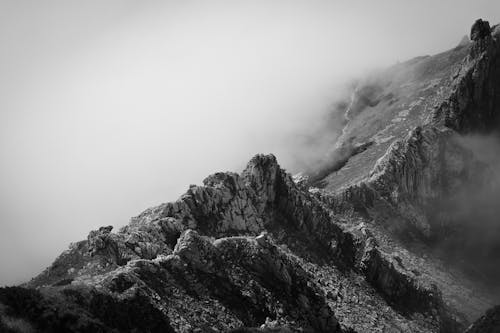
left=0, top=0, right=500, bottom=285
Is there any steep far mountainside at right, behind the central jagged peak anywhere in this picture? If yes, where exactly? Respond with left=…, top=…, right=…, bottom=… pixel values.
left=315, top=16, right=500, bottom=320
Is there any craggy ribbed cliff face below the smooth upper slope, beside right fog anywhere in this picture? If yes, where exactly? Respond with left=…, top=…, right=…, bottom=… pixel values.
left=342, top=127, right=491, bottom=238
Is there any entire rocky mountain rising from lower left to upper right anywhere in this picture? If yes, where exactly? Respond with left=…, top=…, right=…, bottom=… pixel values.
left=0, top=20, right=500, bottom=333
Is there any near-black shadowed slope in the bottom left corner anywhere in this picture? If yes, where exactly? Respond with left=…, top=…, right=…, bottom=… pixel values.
left=0, top=286, right=174, bottom=332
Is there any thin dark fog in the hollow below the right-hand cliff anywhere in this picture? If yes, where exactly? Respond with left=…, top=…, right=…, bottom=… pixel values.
left=435, top=132, right=500, bottom=282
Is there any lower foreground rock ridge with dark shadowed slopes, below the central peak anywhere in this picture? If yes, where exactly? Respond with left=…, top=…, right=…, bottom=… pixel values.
left=4, top=229, right=340, bottom=332
